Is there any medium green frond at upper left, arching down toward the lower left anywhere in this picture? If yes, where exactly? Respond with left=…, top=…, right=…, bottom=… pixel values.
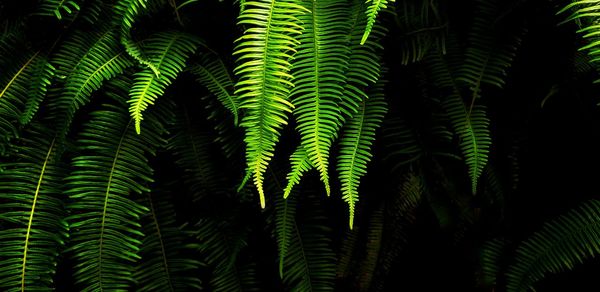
left=48, top=25, right=133, bottom=135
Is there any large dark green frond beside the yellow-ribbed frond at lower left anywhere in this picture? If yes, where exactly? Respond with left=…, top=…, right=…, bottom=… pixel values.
left=66, top=79, right=169, bottom=291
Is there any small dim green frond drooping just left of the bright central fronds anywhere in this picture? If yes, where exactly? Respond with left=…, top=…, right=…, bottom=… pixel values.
left=190, top=55, right=239, bottom=126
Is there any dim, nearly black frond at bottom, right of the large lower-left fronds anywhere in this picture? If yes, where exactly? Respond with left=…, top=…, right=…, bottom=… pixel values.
left=134, top=192, right=201, bottom=291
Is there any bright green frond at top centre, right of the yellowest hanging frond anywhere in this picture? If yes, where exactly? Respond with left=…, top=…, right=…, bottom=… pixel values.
left=291, top=0, right=349, bottom=195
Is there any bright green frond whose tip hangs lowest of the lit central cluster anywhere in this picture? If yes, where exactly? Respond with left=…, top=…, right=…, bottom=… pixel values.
left=337, top=81, right=387, bottom=229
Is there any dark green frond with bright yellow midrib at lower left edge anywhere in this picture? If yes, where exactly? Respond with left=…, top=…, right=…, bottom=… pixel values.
left=0, top=125, right=67, bottom=291
